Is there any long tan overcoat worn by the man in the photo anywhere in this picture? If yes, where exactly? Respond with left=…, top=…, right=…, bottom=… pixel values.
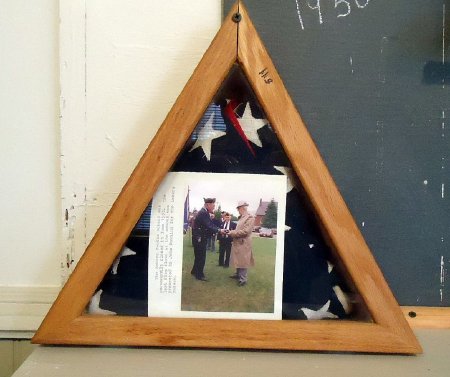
left=229, top=213, right=255, bottom=268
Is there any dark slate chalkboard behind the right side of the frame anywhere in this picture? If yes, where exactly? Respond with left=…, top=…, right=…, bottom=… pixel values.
left=224, top=0, right=450, bottom=306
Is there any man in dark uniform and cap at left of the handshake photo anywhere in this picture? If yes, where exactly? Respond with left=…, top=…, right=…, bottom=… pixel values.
left=191, top=198, right=223, bottom=281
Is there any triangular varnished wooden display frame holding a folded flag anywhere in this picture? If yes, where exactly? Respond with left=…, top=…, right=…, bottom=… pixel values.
left=33, top=2, right=421, bottom=354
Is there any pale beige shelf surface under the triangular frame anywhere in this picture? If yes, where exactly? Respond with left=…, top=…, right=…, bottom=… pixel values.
left=10, top=329, right=450, bottom=377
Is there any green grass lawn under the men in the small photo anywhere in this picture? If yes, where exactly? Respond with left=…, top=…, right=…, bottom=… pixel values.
left=181, top=235, right=276, bottom=313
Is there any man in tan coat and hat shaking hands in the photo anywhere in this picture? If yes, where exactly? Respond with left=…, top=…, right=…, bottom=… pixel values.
left=228, top=201, right=255, bottom=287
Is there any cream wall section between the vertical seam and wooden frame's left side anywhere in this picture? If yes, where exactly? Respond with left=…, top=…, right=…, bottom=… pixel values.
left=61, top=0, right=221, bottom=273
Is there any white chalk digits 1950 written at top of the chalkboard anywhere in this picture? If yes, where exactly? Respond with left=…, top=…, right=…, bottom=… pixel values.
left=295, top=0, right=371, bottom=30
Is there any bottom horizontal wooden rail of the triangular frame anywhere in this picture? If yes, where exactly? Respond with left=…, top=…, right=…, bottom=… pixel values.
left=33, top=316, right=417, bottom=354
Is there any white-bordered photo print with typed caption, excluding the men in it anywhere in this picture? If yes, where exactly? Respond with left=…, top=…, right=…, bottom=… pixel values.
left=148, top=172, right=286, bottom=319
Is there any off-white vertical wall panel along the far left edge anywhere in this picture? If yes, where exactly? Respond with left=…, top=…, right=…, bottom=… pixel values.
left=0, top=0, right=60, bottom=286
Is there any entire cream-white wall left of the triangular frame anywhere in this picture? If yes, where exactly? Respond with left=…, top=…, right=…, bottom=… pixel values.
left=0, top=0, right=221, bottom=336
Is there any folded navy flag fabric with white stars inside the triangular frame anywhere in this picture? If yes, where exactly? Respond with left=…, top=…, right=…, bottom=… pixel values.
left=88, top=66, right=358, bottom=319
